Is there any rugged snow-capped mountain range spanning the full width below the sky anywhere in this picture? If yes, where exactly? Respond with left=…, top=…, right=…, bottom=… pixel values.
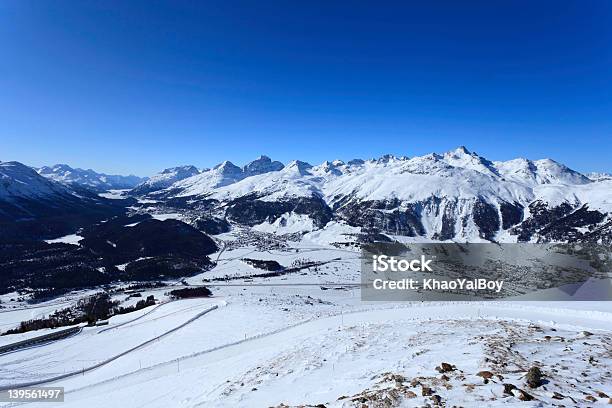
left=0, top=147, right=612, bottom=242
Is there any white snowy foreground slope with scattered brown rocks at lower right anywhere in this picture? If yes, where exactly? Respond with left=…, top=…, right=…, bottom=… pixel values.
left=2, top=296, right=612, bottom=407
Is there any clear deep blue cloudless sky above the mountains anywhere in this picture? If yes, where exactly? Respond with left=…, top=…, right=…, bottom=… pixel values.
left=0, top=0, right=612, bottom=175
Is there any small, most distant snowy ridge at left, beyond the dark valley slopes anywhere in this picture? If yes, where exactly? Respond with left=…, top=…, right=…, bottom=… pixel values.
left=37, top=164, right=145, bottom=191
